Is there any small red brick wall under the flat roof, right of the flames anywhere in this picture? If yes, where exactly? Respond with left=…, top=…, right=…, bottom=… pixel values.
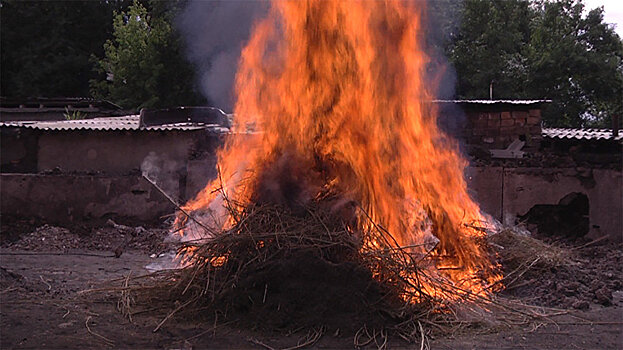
left=465, top=109, right=542, bottom=149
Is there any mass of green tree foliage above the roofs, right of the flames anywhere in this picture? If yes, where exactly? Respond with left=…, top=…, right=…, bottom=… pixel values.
left=447, top=0, right=623, bottom=127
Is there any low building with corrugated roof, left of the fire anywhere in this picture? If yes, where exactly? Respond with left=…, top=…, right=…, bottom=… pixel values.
left=0, top=108, right=229, bottom=225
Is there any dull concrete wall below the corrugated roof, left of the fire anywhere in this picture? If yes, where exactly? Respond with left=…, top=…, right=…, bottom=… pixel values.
left=0, top=130, right=227, bottom=224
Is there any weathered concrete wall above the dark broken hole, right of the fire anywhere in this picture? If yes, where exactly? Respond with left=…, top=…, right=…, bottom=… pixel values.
left=467, top=167, right=623, bottom=242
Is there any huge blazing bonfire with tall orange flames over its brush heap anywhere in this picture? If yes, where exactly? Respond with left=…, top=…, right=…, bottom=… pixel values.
left=151, top=0, right=508, bottom=339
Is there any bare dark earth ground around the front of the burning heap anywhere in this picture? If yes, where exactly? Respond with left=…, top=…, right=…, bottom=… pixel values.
left=0, top=226, right=623, bottom=349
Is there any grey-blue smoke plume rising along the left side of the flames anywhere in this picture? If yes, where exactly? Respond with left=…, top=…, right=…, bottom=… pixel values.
left=177, top=0, right=269, bottom=112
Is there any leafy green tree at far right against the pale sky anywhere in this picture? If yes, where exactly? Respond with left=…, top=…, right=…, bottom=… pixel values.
left=527, top=0, right=623, bottom=127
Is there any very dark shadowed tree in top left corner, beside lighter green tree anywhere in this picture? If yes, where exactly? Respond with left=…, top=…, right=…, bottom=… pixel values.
left=0, top=0, right=117, bottom=97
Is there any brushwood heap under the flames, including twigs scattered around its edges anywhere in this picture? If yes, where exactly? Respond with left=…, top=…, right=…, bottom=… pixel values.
left=81, top=196, right=576, bottom=348
